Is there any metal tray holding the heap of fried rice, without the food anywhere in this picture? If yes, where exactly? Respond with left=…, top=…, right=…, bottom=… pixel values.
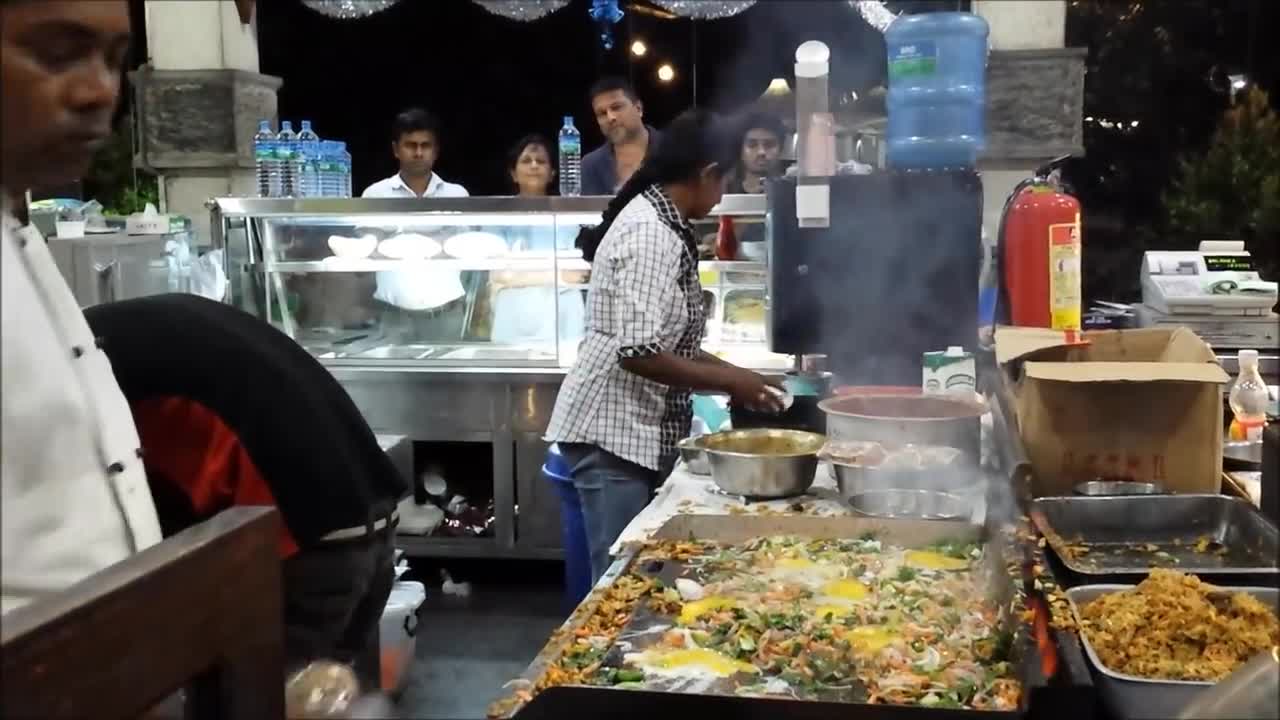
left=1066, top=584, right=1280, bottom=719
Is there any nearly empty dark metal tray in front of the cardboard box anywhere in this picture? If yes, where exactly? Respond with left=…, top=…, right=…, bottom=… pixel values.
left=1030, top=495, right=1280, bottom=577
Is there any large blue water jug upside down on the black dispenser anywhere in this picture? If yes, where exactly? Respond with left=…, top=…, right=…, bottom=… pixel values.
left=884, top=13, right=989, bottom=169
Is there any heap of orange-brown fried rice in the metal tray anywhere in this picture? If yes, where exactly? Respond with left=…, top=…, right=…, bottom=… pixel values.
left=1080, top=569, right=1280, bottom=682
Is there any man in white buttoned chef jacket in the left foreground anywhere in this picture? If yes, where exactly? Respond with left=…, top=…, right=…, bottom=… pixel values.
left=0, top=0, right=160, bottom=612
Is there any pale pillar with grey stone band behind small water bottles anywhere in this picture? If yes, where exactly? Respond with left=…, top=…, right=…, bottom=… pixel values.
left=131, top=0, right=280, bottom=245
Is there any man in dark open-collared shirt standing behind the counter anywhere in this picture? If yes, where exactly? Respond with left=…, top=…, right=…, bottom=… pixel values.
left=582, top=77, right=660, bottom=195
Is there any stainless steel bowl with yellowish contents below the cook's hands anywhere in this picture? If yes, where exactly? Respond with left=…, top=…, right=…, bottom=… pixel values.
left=699, top=429, right=827, bottom=497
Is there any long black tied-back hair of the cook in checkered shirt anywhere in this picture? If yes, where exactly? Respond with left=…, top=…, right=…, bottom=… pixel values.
left=575, top=110, right=739, bottom=263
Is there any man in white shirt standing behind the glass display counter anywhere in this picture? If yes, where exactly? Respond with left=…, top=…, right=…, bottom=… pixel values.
left=361, top=108, right=467, bottom=343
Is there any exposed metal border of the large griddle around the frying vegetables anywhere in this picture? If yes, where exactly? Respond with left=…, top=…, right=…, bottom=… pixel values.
left=492, top=515, right=1096, bottom=720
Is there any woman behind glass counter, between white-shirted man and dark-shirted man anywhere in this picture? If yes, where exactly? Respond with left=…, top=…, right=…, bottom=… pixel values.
left=489, top=135, right=585, bottom=351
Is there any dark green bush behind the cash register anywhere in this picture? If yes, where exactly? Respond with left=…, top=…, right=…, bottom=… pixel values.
left=1165, top=82, right=1280, bottom=279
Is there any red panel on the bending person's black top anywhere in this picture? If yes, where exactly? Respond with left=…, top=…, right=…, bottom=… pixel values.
left=133, top=397, right=298, bottom=559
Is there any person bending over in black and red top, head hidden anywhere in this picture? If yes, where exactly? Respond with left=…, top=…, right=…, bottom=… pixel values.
left=84, top=295, right=408, bottom=689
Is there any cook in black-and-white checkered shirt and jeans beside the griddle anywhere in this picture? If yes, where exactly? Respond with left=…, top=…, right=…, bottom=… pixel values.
left=547, top=111, right=777, bottom=578
